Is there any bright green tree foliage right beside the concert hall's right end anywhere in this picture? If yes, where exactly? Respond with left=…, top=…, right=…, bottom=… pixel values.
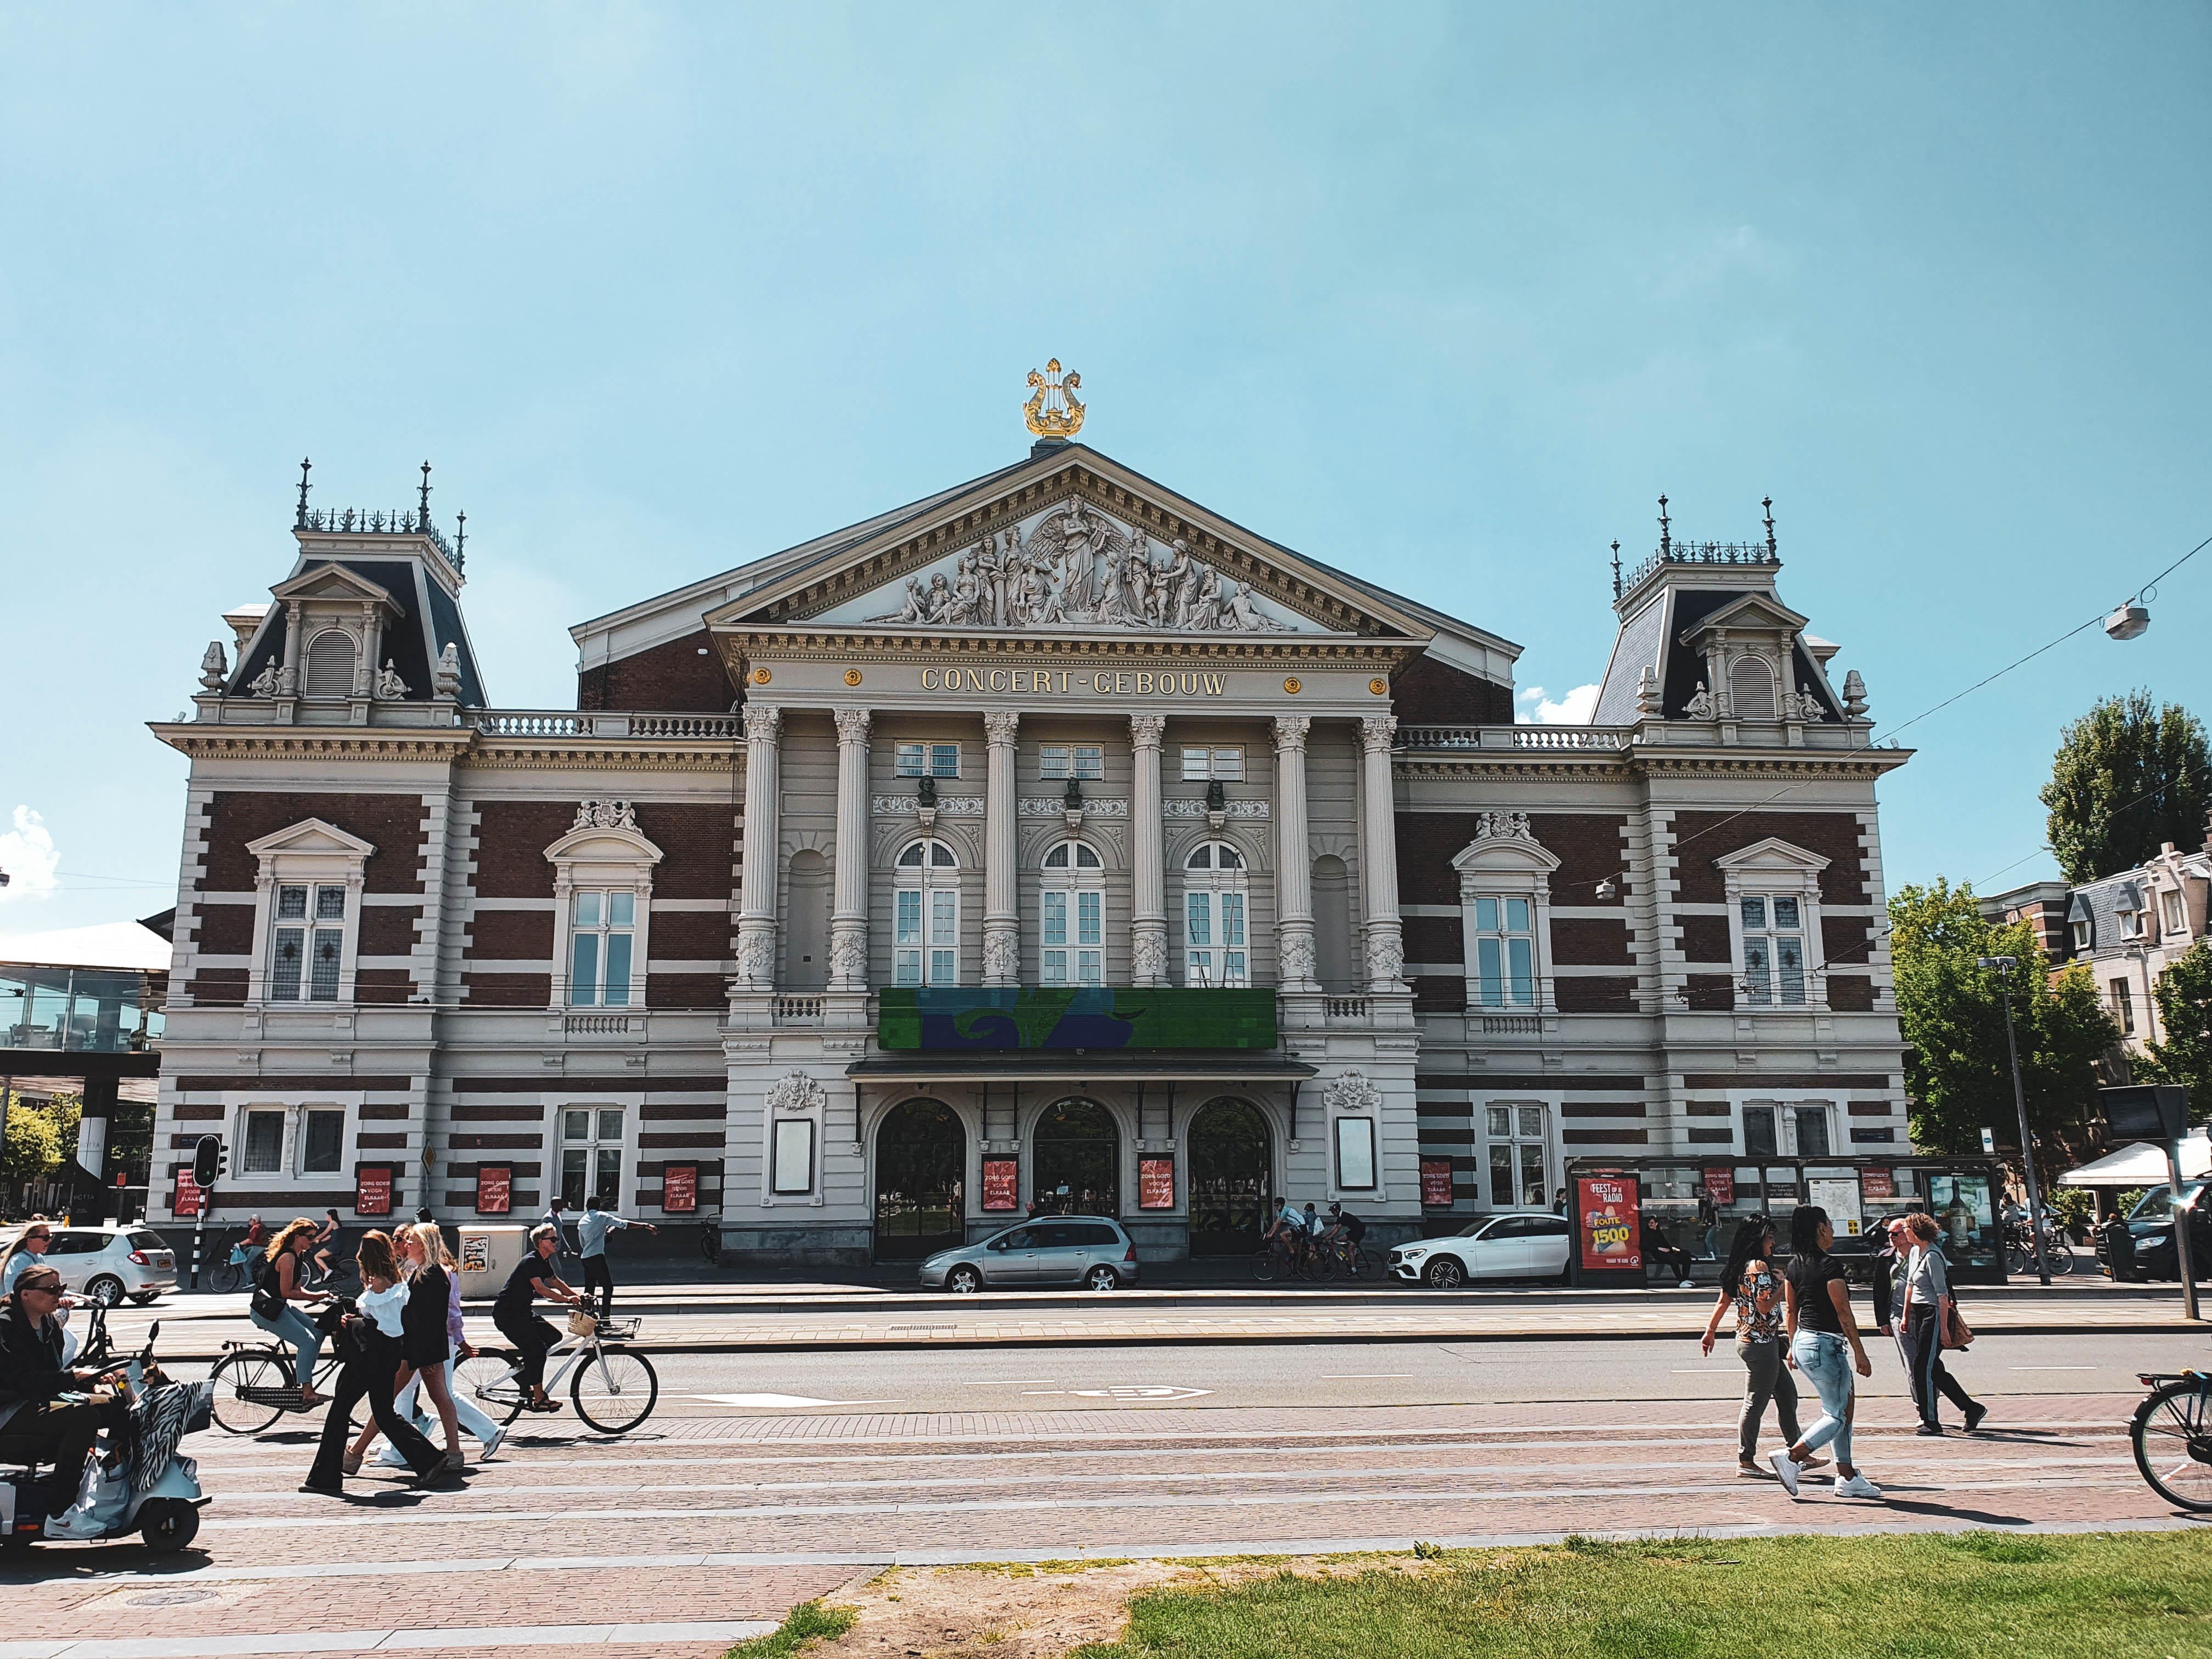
left=1889, top=878, right=2119, bottom=1164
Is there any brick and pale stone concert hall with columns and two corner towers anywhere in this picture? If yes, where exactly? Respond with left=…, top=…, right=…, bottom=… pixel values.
left=155, top=413, right=1905, bottom=1261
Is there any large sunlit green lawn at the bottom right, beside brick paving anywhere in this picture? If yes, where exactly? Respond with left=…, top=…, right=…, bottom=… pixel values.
left=1075, top=1533, right=2212, bottom=1659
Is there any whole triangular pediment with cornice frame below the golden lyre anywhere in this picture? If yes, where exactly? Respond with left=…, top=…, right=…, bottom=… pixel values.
left=706, top=444, right=1434, bottom=644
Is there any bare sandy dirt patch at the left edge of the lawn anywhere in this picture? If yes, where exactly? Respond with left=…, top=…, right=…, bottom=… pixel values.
left=805, top=1555, right=1429, bottom=1659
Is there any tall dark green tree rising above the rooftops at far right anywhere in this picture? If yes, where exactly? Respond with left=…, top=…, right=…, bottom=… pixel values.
left=2042, top=690, right=2212, bottom=883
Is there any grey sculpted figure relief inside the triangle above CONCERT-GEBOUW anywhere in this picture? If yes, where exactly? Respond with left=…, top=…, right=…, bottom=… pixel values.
left=825, top=495, right=1301, bottom=633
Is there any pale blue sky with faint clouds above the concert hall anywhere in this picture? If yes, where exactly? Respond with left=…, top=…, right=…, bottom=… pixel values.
left=0, top=4, right=2212, bottom=934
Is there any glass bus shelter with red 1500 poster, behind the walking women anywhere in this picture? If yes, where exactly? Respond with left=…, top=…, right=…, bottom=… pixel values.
left=1566, top=1155, right=2004, bottom=1285
